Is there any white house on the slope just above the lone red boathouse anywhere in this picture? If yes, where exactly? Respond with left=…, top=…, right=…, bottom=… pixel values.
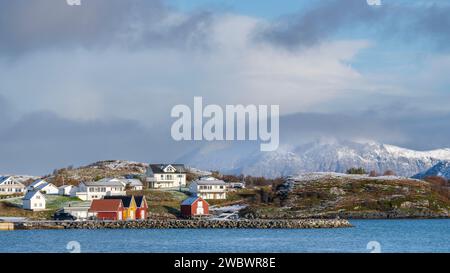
left=189, top=177, right=227, bottom=199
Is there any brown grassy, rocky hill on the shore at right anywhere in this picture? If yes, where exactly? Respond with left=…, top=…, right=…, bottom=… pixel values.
left=243, top=176, right=450, bottom=218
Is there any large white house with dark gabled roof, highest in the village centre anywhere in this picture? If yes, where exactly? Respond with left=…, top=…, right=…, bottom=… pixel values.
left=146, top=164, right=186, bottom=189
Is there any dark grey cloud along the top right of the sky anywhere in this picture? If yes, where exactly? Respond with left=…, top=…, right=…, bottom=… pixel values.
left=255, top=0, right=450, bottom=49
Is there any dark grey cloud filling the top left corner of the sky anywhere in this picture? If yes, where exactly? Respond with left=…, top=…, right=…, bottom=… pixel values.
left=0, top=0, right=212, bottom=55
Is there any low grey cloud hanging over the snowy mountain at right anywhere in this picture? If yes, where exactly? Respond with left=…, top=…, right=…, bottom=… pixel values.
left=280, top=108, right=450, bottom=150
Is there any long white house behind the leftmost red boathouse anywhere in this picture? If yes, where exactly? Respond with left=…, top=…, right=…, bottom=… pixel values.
left=76, top=178, right=126, bottom=201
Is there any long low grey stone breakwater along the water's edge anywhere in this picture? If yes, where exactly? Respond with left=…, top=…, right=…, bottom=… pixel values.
left=15, top=219, right=352, bottom=229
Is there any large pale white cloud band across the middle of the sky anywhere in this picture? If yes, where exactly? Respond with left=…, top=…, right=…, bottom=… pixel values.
left=0, top=15, right=372, bottom=121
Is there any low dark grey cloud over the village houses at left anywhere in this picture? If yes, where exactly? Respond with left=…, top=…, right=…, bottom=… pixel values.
left=0, top=107, right=199, bottom=175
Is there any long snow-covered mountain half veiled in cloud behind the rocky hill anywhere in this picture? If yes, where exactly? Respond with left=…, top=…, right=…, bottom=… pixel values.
left=181, top=140, right=450, bottom=177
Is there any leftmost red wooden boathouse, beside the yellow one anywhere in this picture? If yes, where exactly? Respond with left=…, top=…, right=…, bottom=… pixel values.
left=89, top=199, right=125, bottom=221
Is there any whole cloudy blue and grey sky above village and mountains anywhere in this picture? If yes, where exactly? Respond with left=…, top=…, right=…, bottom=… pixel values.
left=0, top=0, right=450, bottom=175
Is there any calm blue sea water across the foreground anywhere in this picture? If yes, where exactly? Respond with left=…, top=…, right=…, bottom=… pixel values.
left=0, top=220, right=450, bottom=253
